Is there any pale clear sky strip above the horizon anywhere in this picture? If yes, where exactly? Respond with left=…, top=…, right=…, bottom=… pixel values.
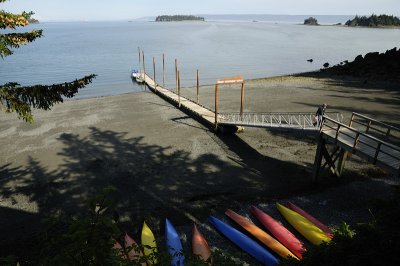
left=0, top=0, right=400, bottom=21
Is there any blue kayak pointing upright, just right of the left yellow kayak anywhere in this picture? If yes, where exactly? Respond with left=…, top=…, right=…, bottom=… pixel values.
left=165, top=219, right=185, bottom=266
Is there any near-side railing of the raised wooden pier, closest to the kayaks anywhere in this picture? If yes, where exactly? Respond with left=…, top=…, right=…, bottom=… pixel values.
left=321, top=116, right=400, bottom=163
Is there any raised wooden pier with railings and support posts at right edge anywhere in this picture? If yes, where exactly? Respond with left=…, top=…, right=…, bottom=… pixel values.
left=314, top=113, right=400, bottom=180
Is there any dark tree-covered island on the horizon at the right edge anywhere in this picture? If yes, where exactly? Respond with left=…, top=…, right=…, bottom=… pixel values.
left=345, top=15, right=400, bottom=27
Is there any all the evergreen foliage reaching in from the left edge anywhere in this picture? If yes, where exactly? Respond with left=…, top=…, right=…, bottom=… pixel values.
left=0, top=0, right=96, bottom=122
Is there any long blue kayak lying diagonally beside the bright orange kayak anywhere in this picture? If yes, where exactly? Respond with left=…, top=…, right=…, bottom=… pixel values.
left=208, top=216, right=278, bottom=265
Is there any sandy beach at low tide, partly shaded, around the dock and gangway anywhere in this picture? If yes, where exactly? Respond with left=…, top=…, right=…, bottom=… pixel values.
left=0, top=75, right=400, bottom=262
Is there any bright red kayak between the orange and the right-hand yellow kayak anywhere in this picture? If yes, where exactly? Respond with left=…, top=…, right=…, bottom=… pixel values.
left=250, top=206, right=306, bottom=259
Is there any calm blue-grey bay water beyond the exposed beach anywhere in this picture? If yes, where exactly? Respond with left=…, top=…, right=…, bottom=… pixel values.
left=0, top=16, right=400, bottom=98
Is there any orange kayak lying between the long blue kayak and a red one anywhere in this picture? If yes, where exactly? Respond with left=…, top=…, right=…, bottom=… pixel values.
left=225, top=209, right=298, bottom=259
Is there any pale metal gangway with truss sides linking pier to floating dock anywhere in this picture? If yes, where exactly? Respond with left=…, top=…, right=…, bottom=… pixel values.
left=218, top=112, right=343, bottom=130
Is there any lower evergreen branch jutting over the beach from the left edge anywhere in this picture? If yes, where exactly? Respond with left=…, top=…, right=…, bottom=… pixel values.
left=0, top=74, right=96, bottom=123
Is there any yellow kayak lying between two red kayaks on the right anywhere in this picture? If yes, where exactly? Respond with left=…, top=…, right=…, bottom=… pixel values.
left=276, top=203, right=331, bottom=245
